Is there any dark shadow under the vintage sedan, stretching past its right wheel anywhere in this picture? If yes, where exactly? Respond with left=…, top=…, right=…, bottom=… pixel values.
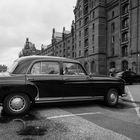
left=33, top=99, right=134, bottom=111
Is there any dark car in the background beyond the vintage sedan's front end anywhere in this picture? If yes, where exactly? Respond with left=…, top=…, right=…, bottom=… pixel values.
left=116, top=71, right=140, bottom=85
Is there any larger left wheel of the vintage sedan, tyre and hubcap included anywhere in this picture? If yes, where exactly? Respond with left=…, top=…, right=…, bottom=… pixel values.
left=3, top=93, right=31, bottom=115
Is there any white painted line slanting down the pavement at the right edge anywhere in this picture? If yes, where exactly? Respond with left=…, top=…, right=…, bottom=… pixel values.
left=126, top=87, right=140, bottom=119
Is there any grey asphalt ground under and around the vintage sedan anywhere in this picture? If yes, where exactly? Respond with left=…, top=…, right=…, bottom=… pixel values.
left=0, top=85, right=140, bottom=140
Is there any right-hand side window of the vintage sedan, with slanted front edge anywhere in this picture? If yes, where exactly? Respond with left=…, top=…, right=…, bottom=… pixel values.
left=63, top=62, right=85, bottom=75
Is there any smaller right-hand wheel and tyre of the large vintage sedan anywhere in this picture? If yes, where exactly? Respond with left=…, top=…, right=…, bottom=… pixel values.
left=104, top=88, right=119, bottom=106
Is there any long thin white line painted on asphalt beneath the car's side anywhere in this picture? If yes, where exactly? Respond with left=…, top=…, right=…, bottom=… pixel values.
left=47, top=112, right=103, bottom=119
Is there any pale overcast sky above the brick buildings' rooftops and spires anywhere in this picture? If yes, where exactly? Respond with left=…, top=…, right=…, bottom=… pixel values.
left=0, top=0, right=77, bottom=66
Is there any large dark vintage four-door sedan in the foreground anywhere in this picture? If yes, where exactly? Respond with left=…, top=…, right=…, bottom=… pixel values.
left=0, top=56, right=126, bottom=115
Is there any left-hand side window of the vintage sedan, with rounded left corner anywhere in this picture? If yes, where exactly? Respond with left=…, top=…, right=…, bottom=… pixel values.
left=31, top=61, right=60, bottom=75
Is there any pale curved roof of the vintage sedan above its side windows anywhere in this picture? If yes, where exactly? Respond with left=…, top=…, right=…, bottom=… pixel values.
left=16, top=55, right=79, bottom=63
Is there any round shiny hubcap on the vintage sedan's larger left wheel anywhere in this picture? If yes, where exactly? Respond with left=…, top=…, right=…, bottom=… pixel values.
left=9, top=96, right=25, bottom=112
